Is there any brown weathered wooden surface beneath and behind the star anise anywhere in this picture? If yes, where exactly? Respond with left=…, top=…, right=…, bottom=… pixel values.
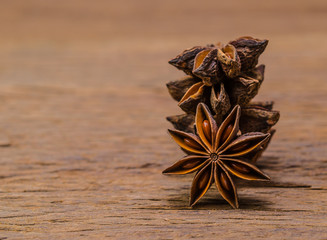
left=0, top=0, right=327, bottom=239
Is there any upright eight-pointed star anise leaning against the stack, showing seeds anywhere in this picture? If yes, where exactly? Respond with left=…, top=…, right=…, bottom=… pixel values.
left=163, top=103, right=270, bottom=208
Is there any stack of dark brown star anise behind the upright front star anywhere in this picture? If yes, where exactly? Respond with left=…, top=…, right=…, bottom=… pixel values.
left=167, top=37, right=279, bottom=163
